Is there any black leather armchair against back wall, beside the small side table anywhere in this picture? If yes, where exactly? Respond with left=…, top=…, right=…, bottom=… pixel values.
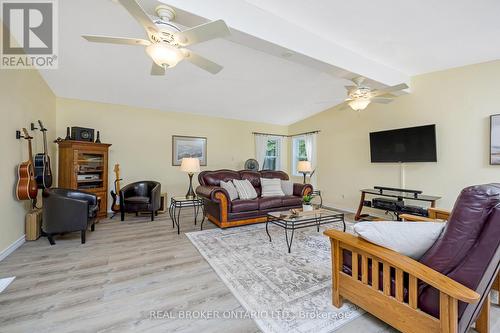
left=120, top=181, right=161, bottom=221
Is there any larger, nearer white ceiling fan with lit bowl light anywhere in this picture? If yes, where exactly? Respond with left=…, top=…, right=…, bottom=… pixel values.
left=82, top=0, right=230, bottom=75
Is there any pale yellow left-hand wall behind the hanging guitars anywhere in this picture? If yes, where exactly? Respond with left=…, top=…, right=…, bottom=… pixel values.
left=0, top=68, right=56, bottom=253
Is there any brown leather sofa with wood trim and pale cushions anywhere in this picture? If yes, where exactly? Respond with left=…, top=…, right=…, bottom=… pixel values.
left=196, top=170, right=312, bottom=228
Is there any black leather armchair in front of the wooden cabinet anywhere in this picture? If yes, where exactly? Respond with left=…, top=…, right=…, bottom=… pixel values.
left=42, top=188, right=99, bottom=245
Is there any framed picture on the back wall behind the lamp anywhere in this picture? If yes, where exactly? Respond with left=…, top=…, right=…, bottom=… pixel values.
left=172, top=135, right=207, bottom=166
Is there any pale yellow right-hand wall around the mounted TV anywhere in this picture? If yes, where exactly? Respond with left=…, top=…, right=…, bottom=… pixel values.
left=288, top=61, right=500, bottom=210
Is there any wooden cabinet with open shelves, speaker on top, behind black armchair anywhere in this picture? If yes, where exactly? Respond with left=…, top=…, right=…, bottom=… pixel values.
left=58, top=140, right=111, bottom=217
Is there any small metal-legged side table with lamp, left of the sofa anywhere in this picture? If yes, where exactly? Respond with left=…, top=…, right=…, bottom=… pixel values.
left=168, top=157, right=205, bottom=234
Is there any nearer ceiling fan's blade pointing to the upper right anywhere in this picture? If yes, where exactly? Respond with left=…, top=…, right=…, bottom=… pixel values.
left=176, top=20, right=231, bottom=46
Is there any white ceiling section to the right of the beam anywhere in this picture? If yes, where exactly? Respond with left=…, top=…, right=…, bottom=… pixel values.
left=242, top=0, right=500, bottom=75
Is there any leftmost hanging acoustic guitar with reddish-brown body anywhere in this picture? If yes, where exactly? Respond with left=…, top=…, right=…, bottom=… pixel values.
left=16, top=128, right=38, bottom=200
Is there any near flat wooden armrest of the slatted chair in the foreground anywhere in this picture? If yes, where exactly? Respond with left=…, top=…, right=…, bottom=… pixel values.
left=324, top=230, right=480, bottom=303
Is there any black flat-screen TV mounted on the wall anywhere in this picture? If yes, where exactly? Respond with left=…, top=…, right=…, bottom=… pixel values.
left=370, top=125, right=437, bottom=163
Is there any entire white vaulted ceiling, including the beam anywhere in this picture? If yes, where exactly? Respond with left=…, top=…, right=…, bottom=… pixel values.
left=42, top=0, right=500, bottom=124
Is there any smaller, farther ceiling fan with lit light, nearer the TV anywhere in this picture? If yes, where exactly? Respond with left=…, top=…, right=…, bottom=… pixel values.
left=340, top=77, right=408, bottom=111
